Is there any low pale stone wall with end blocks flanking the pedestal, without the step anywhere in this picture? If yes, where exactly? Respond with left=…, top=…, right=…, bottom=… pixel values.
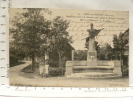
left=65, top=60, right=121, bottom=75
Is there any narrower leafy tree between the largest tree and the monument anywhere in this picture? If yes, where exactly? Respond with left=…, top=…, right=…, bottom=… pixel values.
left=48, top=16, right=72, bottom=74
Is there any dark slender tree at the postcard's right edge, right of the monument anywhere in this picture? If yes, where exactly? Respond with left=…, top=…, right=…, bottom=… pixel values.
left=113, top=29, right=129, bottom=76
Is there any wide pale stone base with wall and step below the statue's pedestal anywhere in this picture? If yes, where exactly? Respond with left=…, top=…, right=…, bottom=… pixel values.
left=65, top=60, right=122, bottom=78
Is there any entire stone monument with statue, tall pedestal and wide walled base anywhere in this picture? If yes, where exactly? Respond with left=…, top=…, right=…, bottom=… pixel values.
left=65, top=23, right=121, bottom=78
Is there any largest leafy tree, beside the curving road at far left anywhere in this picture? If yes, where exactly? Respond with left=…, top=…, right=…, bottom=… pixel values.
left=11, top=8, right=50, bottom=70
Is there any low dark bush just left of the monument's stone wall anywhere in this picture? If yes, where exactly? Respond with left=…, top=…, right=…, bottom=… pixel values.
left=49, top=67, right=65, bottom=76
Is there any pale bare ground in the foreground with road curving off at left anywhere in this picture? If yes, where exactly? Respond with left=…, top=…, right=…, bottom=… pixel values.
left=10, top=62, right=129, bottom=87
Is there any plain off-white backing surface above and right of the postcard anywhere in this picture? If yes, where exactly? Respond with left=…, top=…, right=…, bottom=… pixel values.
left=11, top=0, right=133, bottom=86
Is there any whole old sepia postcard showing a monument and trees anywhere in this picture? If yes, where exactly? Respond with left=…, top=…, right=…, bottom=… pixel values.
left=9, top=8, right=130, bottom=87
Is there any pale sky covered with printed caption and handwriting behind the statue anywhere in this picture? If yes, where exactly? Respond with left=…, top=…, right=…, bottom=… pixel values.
left=10, top=8, right=129, bottom=50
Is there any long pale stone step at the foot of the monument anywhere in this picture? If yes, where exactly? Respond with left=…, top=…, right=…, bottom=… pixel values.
left=70, top=72, right=120, bottom=78
